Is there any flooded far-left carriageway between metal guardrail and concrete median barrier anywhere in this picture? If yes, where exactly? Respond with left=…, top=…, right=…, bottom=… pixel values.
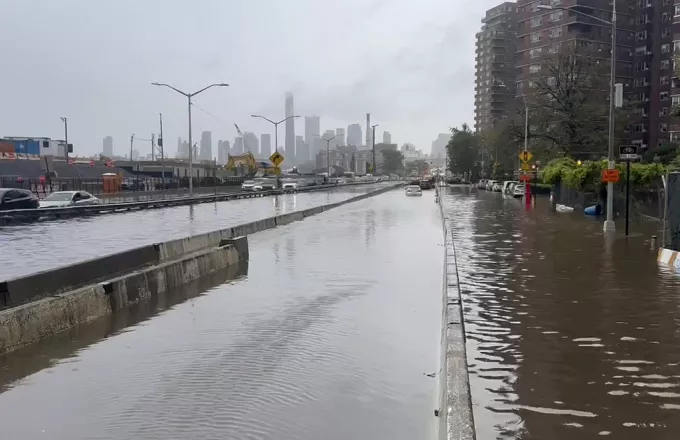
left=0, top=183, right=384, bottom=280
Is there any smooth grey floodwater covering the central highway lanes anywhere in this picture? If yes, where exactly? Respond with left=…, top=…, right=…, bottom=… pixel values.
left=0, top=190, right=444, bottom=440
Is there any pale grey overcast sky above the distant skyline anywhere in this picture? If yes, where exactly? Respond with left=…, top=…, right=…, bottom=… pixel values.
left=0, top=0, right=499, bottom=156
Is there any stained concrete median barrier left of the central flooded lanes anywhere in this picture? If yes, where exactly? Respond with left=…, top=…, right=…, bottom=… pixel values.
left=0, top=180, right=397, bottom=354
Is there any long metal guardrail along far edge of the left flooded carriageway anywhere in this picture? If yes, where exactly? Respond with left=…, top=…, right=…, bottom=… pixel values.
left=0, top=181, right=388, bottom=225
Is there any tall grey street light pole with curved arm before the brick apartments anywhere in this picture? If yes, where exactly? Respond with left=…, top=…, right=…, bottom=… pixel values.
left=538, top=0, right=616, bottom=232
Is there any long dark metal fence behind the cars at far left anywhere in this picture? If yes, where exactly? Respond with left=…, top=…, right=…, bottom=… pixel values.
left=0, top=176, right=244, bottom=198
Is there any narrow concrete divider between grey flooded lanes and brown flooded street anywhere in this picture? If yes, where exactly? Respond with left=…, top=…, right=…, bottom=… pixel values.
left=437, top=188, right=476, bottom=440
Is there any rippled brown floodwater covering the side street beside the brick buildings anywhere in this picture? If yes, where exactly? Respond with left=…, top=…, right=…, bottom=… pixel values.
left=443, top=188, right=680, bottom=440
